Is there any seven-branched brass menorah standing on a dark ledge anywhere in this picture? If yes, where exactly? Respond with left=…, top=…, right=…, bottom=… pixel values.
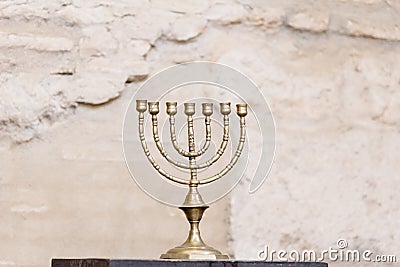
left=136, top=100, right=247, bottom=259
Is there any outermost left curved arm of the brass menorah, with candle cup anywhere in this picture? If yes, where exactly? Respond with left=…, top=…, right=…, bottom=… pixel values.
left=136, top=100, right=189, bottom=185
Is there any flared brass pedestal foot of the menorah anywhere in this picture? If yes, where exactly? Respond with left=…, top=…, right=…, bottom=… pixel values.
left=160, top=205, right=229, bottom=260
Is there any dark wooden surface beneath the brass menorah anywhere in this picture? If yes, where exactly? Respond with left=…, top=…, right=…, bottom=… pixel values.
left=51, top=259, right=328, bottom=267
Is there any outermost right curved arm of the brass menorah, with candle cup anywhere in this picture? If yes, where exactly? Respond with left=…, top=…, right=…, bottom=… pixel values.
left=199, top=104, right=247, bottom=185
